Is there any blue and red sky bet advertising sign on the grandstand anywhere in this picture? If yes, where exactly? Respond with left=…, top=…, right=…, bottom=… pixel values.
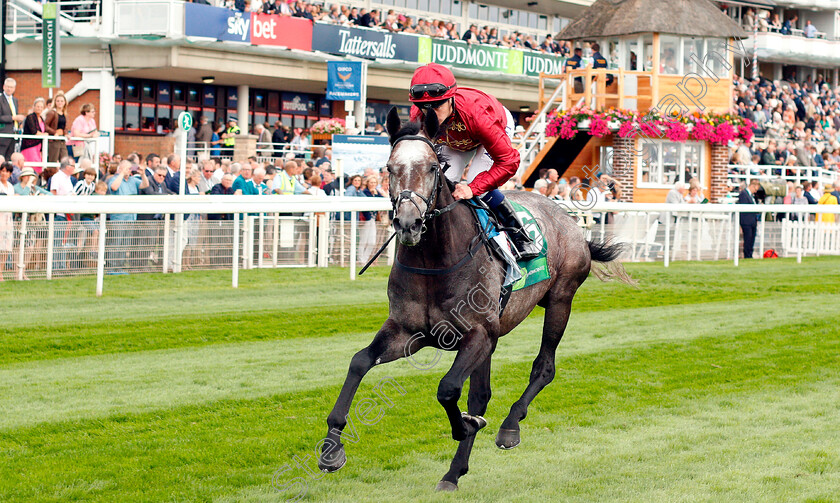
left=184, top=3, right=312, bottom=51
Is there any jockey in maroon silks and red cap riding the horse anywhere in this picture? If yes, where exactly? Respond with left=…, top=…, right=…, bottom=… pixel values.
left=409, top=63, right=540, bottom=260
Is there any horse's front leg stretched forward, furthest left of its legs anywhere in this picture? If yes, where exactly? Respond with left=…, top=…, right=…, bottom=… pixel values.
left=318, top=319, right=419, bottom=472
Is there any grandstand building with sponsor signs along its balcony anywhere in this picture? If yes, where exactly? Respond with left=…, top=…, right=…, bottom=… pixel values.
left=5, top=0, right=591, bottom=156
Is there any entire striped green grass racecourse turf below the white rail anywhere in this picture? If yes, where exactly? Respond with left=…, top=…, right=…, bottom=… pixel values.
left=0, top=258, right=840, bottom=502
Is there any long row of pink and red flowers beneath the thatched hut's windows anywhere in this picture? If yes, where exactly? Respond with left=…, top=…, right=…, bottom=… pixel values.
left=545, top=107, right=755, bottom=145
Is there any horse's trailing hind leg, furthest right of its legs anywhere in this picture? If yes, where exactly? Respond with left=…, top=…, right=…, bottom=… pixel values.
left=496, top=290, right=574, bottom=449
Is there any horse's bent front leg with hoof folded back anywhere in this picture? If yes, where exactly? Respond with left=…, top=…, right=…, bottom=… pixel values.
left=437, top=325, right=495, bottom=441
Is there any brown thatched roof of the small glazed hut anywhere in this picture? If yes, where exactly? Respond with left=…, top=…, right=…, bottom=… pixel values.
left=557, top=0, right=748, bottom=40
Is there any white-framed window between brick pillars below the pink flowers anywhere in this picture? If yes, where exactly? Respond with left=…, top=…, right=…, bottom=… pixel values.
left=637, top=138, right=706, bottom=188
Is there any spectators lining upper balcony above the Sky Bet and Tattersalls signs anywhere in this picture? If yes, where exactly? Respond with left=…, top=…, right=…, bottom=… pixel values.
left=192, top=0, right=572, bottom=56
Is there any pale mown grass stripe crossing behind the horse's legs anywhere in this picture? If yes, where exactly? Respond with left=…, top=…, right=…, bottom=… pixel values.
left=0, top=296, right=840, bottom=429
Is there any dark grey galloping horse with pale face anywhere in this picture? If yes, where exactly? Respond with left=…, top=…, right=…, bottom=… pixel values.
left=318, top=109, right=631, bottom=491
